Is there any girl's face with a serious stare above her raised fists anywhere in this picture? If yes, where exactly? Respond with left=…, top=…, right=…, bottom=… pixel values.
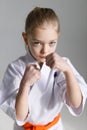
left=22, top=24, right=59, bottom=63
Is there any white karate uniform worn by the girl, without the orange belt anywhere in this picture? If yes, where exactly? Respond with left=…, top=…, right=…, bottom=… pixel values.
left=0, top=51, right=87, bottom=130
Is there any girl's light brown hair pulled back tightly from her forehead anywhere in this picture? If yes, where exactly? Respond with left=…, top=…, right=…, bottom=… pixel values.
left=25, top=7, right=60, bottom=34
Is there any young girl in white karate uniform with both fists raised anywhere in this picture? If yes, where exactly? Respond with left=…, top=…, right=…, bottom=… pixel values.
left=0, top=7, right=87, bottom=130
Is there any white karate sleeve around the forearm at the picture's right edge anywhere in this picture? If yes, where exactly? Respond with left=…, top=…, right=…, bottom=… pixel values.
left=66, top=59, right=87, bottom=116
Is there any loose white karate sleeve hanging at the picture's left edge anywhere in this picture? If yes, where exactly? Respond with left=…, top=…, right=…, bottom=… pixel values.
left=0, top=64, right=21, bottom=120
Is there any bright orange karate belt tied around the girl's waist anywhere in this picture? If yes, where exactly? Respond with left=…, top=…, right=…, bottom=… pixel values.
left=22, top=114, right=60, bottom=130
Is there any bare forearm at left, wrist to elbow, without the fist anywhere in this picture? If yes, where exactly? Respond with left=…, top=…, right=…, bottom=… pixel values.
left=15, top=86, right=29, bottom=121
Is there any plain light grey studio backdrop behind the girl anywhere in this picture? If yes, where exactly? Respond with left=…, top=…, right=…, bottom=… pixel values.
left=0, top=0, right=87, bottom=130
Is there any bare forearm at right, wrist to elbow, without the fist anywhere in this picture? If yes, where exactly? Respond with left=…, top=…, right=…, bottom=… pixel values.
left=65, top=70, right=82, bottom=108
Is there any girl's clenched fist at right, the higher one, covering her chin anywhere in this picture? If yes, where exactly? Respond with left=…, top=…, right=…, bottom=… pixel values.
left=46, top=53, right=70, bottom=72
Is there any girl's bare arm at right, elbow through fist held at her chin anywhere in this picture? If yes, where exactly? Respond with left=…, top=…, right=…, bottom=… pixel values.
left=46, top=53, right=82, bottom=108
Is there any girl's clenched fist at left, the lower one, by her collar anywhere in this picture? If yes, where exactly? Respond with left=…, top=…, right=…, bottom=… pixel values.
left=21, top=64, right=40, bottom=87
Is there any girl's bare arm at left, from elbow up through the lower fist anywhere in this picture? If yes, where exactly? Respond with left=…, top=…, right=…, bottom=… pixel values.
left=15, top=65, right=40, bottom=121
